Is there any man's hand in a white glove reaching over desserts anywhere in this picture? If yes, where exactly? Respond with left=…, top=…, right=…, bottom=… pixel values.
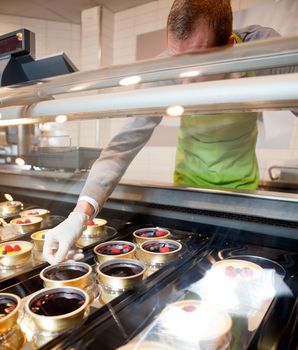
left=43, top=211, right=89, bottom=265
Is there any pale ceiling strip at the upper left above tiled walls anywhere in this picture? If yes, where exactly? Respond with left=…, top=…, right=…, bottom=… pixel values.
left=0, top=0, right=152, bottom=23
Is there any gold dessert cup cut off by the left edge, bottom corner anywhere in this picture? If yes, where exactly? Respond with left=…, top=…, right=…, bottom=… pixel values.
left=0, top=293, right=21, bottom=334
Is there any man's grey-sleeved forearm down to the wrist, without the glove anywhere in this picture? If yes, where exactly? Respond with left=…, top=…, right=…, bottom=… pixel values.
left=75, top=117, right=162, bottom=216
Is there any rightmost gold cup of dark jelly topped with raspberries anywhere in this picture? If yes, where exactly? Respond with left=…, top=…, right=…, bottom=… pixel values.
left=139, top=239, right=182, bottom=266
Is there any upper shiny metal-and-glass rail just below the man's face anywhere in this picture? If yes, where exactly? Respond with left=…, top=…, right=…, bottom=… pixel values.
left=0, top=36, right=298, bottom=107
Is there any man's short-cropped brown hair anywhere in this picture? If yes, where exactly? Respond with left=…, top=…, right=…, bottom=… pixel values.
left=167, top=0, right=233, bottom=46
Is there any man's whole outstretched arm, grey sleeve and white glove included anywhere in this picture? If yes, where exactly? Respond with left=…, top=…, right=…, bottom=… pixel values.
left=43, top=113, right=162, bottom=264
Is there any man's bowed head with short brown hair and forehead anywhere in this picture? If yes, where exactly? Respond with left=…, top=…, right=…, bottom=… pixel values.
left=167, top=0, right=233, bottom=54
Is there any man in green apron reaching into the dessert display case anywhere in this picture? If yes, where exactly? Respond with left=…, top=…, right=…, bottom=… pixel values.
left=44, top=0, right=296, bottom=264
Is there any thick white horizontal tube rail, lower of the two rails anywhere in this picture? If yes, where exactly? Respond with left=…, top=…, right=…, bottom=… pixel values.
left=0, top=73, right=298, bottom=126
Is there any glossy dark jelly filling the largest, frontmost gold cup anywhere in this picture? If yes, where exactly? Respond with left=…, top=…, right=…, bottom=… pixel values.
left=30, top=292, right=85, bottom=316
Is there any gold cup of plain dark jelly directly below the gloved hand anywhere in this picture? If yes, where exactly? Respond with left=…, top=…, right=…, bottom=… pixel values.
left=40, top=261, right=92, bottom=289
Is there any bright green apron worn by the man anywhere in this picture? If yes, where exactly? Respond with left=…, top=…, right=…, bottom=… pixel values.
left=174, top=33, right=259, bottom=190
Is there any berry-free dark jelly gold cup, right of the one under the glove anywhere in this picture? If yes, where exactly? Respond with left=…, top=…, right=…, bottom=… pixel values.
left=96, top=259, right=145, bottom=291
